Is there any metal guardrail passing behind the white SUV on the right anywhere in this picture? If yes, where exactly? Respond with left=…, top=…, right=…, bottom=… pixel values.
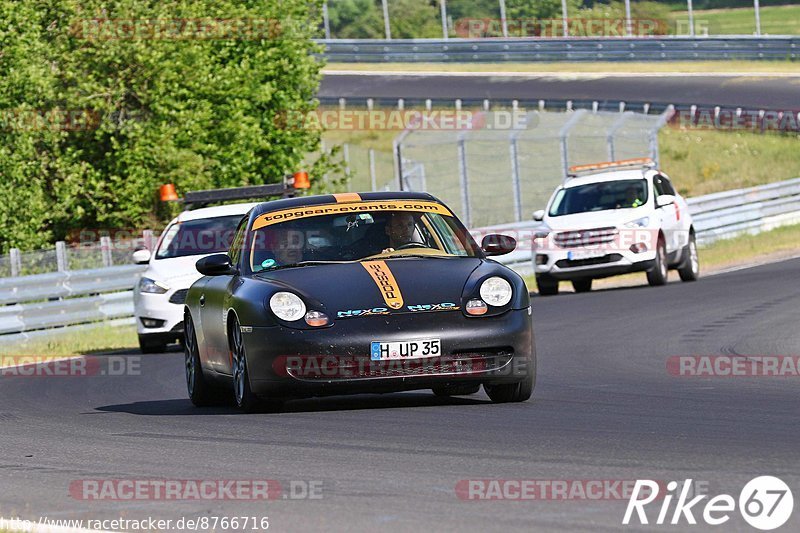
left=473, top=178, right=800, bottom=274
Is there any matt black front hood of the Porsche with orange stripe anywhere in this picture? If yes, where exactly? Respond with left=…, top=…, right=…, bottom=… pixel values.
left=256, top=257, right=483, bottom=316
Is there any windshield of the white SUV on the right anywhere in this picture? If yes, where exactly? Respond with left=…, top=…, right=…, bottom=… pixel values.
left=549, top=179, right=647, bottom=217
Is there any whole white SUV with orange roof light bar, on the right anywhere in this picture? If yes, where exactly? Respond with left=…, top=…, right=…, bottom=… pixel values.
left=533, top=159, right=700, bottom=295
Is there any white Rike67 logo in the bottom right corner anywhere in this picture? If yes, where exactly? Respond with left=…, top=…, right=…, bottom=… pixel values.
left=622, top=476, right=794, bottom=531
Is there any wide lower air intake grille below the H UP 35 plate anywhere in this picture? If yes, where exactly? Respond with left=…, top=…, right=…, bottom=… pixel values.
left=285, top=352, right=513, bottom=381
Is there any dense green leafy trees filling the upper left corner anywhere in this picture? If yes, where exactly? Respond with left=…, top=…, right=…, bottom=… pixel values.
left=0, top=0, right=328, bottom=251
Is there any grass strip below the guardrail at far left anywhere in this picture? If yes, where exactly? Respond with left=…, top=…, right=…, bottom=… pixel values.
left=0, top=326, right=139, bottom=357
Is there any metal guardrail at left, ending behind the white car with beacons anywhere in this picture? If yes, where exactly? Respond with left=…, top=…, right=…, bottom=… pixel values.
left=0, top=265, right=145, bottom=343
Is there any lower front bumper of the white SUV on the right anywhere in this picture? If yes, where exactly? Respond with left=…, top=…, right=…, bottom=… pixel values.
left=533, top=248, right=656, bottom=280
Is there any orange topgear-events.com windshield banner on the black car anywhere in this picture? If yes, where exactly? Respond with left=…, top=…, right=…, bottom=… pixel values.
left=252, top=200, right=453, bottom=231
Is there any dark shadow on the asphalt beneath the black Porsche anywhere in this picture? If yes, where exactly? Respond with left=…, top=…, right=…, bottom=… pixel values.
left=96, top=393, right=492, bottom=416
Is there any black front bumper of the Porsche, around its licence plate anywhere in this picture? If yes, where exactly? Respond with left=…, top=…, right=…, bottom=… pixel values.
left=243, top=309, right=535, bottom=397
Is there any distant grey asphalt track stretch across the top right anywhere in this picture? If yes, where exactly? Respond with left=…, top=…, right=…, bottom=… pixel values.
left=318, top=72, right=800, bottom=110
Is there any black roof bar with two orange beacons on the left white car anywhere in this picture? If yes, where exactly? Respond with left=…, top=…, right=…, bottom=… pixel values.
left=161, top=172, right=310, bottom=209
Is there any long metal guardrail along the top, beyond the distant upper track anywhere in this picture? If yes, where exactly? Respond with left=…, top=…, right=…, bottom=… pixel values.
left=318, top=35, right=800, bottom=63
